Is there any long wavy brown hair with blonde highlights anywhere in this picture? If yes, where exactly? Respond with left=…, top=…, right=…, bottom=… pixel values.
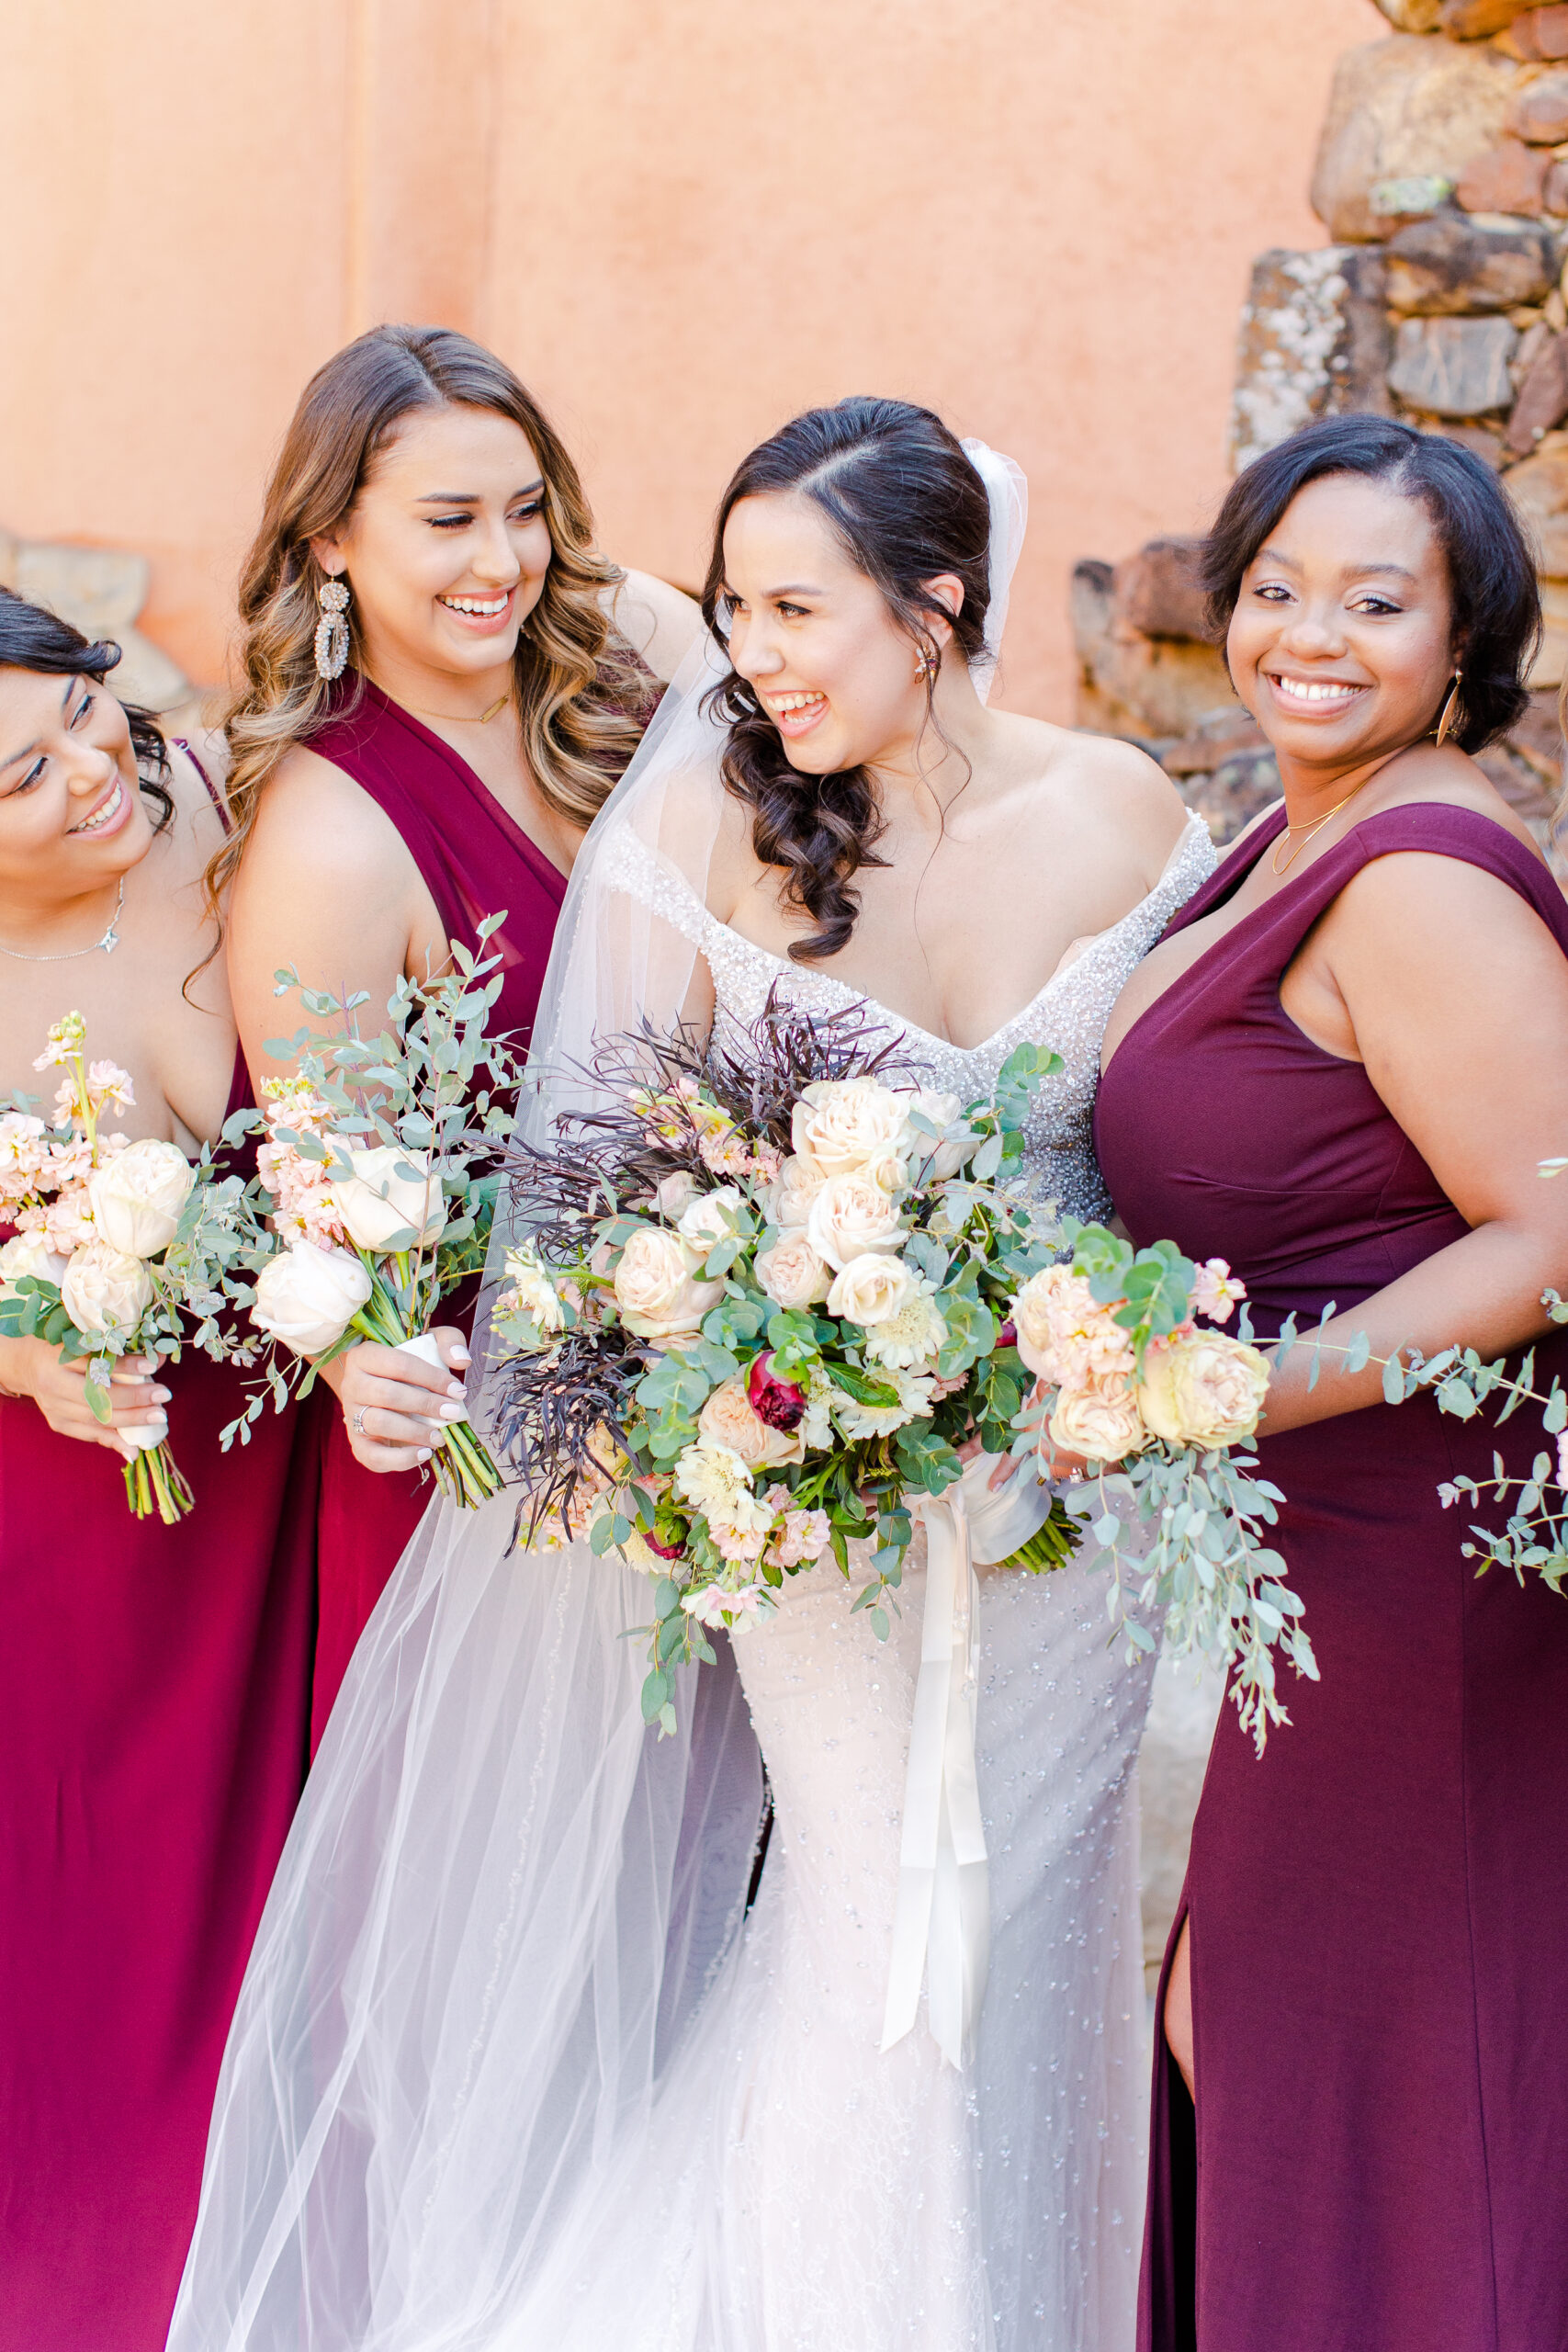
left=207, top=327, right=649, bottom=908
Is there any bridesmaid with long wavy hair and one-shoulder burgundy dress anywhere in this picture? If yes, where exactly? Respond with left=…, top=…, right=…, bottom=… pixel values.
left=214, top=327, right=701, bottom=1750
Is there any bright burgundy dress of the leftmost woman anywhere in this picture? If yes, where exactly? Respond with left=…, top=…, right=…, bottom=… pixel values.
left=0, top=752, right=315, bottom=2352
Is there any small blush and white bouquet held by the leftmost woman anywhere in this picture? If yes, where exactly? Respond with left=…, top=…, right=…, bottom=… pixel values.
left=0, top=1013, right=247, bottom=1526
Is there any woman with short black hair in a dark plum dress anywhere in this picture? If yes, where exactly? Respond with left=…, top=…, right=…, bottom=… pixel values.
left=1098, top=416, right=1568, bottom=2352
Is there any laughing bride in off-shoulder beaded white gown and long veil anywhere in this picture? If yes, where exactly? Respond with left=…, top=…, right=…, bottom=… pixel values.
left=169, top=400, right=1213, bottom=2352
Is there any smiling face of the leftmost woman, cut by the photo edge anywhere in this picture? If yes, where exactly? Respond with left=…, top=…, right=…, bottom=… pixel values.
left=0, top=671, right=152, bottom=900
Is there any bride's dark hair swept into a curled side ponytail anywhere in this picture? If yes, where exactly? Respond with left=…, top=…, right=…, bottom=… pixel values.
left=703, top=398, right=989, bottom=962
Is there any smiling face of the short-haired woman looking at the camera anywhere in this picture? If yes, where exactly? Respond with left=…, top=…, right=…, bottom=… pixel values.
left=1224, top=473, right=1464, bottom=774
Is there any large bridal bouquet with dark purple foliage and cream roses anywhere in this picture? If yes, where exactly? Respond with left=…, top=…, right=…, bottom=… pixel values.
left=493, top=1004, right=1079, bottom=1731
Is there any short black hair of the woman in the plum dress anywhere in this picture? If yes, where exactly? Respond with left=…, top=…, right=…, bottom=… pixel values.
left=1199, top=416, right=1540, bottom=752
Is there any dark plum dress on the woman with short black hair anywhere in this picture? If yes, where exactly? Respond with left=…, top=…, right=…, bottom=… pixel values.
left=1096, top=805, right=1568, bottom=2352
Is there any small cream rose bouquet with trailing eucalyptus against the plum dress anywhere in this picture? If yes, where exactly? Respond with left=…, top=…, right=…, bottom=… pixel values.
left=1013, top=1218, right=1316, bottom=1755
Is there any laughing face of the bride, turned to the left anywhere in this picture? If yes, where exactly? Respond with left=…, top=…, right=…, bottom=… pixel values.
left=724, top=492, right=962, bottom=776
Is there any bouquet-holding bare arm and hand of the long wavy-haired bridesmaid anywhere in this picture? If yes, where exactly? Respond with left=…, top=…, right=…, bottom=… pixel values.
left=228, top=748, right=468, bottom=1470
